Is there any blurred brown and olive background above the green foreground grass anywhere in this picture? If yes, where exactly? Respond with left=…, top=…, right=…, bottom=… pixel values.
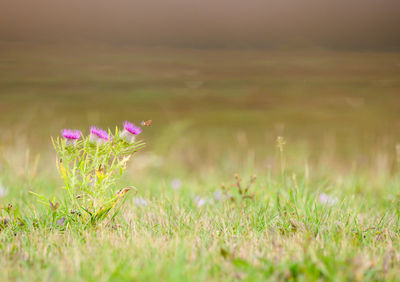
left=0, top=0, right=400, bottom=183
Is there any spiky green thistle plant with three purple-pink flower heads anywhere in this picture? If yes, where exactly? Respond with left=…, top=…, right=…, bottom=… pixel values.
left=34, top=121, right=144, bottom=224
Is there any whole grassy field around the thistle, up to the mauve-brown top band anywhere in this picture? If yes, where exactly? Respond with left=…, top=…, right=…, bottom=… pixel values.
left=0, top=43, right=400, bottom=281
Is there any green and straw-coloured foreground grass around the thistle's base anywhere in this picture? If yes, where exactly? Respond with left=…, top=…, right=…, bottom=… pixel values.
left=0, top=152, right=400, bottom=281
